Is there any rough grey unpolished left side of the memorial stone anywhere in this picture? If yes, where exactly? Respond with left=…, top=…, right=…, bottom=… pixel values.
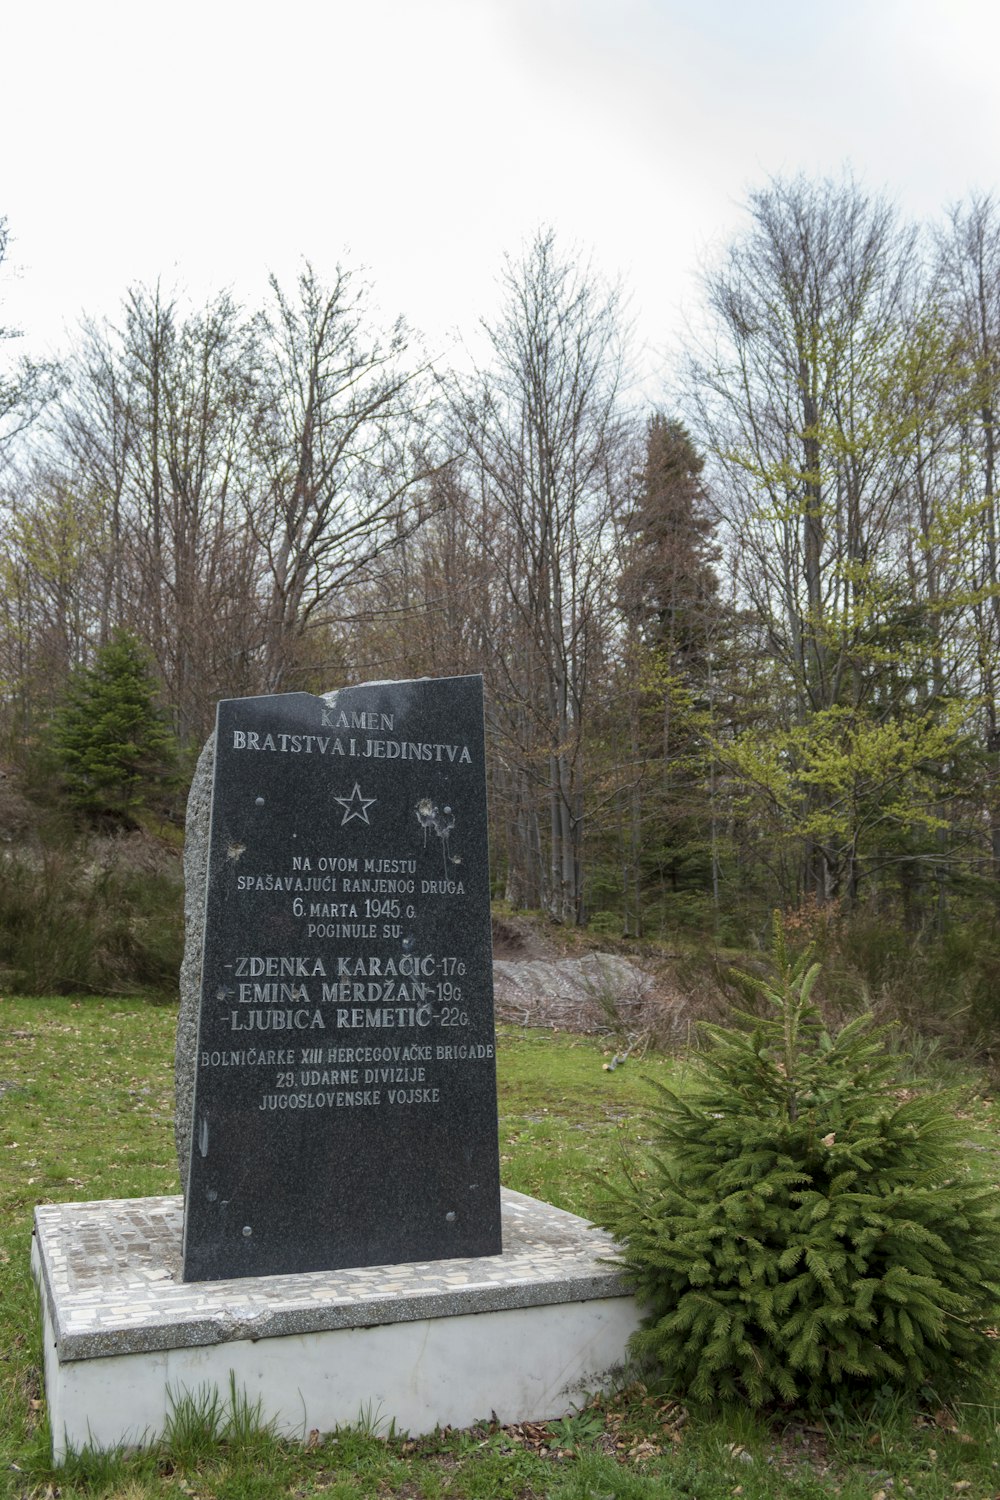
left=174, top=734, right=216, bottom=1193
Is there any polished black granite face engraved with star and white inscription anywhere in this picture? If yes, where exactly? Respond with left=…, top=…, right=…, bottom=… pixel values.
left=183, top=677, right=501, bottom=1281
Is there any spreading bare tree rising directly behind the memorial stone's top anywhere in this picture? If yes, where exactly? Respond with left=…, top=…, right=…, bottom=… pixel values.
left=246, top=266, right=433, bottom=692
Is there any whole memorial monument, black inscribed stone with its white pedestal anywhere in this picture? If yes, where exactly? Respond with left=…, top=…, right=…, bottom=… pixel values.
left=31, top=678, right=639, bottom=1463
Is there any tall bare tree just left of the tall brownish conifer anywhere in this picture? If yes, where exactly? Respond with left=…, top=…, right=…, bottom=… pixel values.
left=454, top=231, right=625, bottom=923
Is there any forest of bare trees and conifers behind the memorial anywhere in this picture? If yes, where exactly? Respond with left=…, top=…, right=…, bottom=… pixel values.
left=0, top=177, right=1000, bottom=1041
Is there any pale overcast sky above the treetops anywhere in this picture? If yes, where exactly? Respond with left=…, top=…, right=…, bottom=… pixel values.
left=0, top=0, right=1000, bottom=378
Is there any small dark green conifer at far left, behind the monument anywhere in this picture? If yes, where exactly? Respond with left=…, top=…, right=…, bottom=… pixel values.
left=52, top=630, right=177, bottom=821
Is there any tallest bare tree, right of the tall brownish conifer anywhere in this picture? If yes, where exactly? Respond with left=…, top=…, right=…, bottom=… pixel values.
left=690, top=179, right=915, bottom=902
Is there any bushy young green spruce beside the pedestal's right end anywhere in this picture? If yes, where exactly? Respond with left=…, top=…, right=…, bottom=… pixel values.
left=600, top=918, right=1000, bottom=1410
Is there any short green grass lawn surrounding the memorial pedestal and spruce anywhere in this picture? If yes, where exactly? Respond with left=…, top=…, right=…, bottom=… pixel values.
left=0, top=999, right=1000, bottom=1500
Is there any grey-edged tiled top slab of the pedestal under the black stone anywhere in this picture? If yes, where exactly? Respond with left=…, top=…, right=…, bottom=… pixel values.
left=34, top=1190, right=631, bottom=1364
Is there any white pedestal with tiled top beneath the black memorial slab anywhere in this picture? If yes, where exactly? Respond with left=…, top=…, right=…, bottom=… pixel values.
left=31, top=1193, right=639, bottom=1463
